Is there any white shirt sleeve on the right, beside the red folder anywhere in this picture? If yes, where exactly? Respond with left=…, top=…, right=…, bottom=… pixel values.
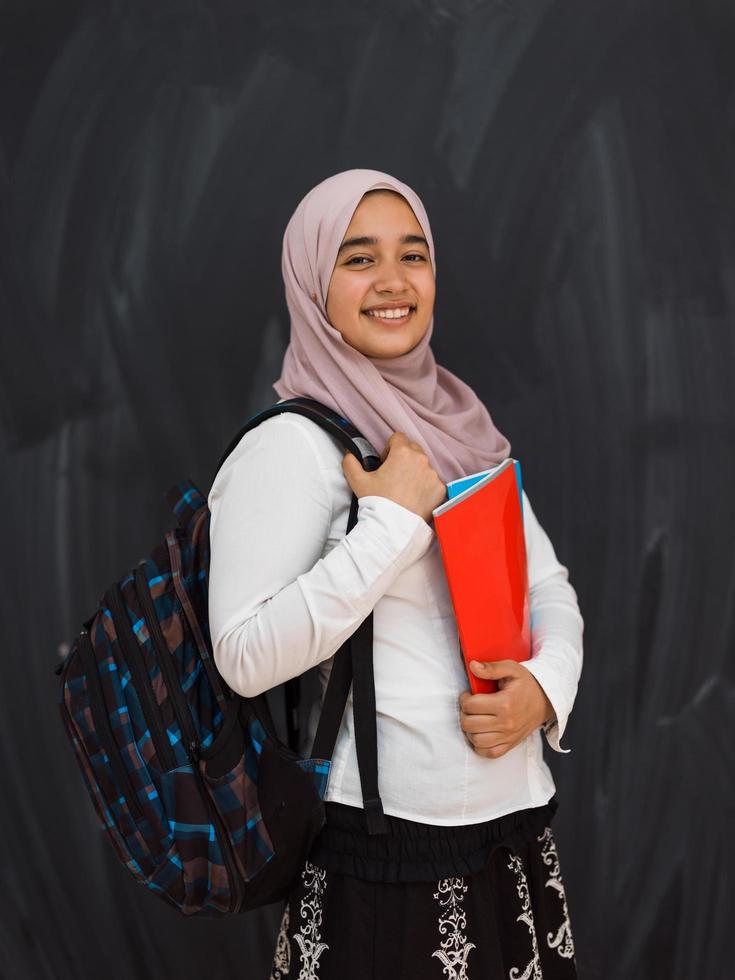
left=523, top=490, right=584, bottom=752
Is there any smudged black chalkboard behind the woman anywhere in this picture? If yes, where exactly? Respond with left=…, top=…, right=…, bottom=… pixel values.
left=0, top=0, right=735, bottom=980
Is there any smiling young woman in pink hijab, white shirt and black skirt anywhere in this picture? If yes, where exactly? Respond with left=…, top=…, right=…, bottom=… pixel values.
left=209, top=170, right=583, bottom=980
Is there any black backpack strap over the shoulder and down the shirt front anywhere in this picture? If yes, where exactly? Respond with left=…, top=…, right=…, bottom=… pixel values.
left=215, top=396, right=387, bottom=834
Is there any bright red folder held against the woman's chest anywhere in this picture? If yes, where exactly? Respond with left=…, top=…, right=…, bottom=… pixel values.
left=433, top=457, right=531, bottom=694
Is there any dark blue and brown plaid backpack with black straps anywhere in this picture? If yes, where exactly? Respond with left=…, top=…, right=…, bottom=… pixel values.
left=55, top=397, right=386, bottom=917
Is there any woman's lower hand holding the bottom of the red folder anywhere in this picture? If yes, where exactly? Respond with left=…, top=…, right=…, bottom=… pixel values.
left=459, top=660, right=556, bottom=759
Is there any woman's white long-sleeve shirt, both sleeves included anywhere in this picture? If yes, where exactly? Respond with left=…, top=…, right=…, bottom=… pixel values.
left=208, top=399, right=584, bottom=825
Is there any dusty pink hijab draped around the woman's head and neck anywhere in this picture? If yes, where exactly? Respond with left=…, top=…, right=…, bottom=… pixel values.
left=273, top=169, right=510, bottom=483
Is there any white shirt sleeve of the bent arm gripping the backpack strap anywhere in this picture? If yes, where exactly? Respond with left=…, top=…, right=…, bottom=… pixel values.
left=208, top=415, right=434, bottom=697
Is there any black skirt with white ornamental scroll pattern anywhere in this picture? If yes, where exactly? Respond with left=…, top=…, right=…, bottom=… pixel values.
left=270, top=797, right=577, bottom=980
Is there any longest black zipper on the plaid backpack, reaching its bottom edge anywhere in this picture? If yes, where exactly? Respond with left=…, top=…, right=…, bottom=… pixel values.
left=135, top=559, right=242, bottom=912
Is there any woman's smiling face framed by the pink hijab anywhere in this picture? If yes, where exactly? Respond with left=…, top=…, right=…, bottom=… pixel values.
left=327, top=190, right=436, bottom=357
